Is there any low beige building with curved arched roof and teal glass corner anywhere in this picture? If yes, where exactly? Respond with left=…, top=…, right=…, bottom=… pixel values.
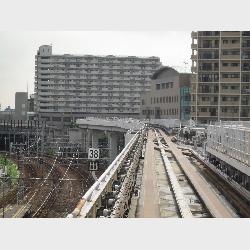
left=141, top=67, right=191, bottom=120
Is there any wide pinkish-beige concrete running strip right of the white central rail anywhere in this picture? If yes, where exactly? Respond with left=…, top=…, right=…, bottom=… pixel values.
left=159, top=130, right=235, bottom=218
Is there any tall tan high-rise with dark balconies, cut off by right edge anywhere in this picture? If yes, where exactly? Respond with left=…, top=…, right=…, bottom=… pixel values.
left=191, top=31, right=250, bottom=123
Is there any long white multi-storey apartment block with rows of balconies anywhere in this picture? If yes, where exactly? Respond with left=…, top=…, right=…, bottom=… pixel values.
left=35, top=45, right=161, bottom=123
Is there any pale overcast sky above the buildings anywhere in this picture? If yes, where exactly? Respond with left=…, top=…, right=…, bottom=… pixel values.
left=0, top=31, right=191, bottom=110
